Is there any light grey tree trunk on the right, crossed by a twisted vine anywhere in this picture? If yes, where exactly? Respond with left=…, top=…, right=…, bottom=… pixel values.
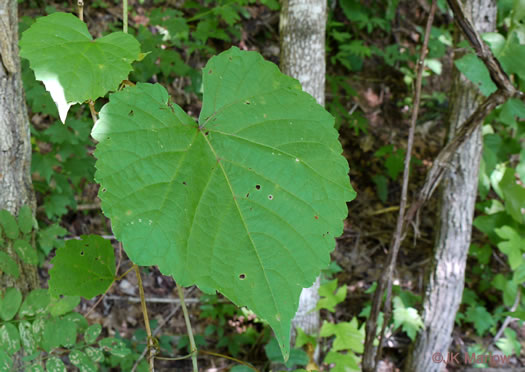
left=405, top=0, right=497, bottom=372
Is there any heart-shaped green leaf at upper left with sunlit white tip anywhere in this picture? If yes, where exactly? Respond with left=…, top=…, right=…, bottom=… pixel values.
left=20, top=12, right=140, bottom=123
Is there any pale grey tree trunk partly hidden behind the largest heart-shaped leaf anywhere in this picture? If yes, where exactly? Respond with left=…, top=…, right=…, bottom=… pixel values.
left=279, top=0, right=326, bottom=359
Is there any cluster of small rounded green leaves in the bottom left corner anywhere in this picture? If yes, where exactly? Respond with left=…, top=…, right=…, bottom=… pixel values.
left=0, top=288, right=135, bottom=371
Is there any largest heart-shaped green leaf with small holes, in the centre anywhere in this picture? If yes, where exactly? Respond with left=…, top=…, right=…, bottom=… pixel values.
left=92, top=48, right=355, bottom=357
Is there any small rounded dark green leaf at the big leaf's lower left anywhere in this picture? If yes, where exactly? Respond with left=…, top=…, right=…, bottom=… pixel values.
left=49, top=235, right=115, bottom=299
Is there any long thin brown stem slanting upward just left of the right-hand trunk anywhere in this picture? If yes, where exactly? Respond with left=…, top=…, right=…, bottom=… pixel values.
left=363, top=0, right=437, bottom=371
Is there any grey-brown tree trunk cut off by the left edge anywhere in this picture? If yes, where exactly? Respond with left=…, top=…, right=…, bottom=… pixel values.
left=0, top=0, right=38, bottom=293
